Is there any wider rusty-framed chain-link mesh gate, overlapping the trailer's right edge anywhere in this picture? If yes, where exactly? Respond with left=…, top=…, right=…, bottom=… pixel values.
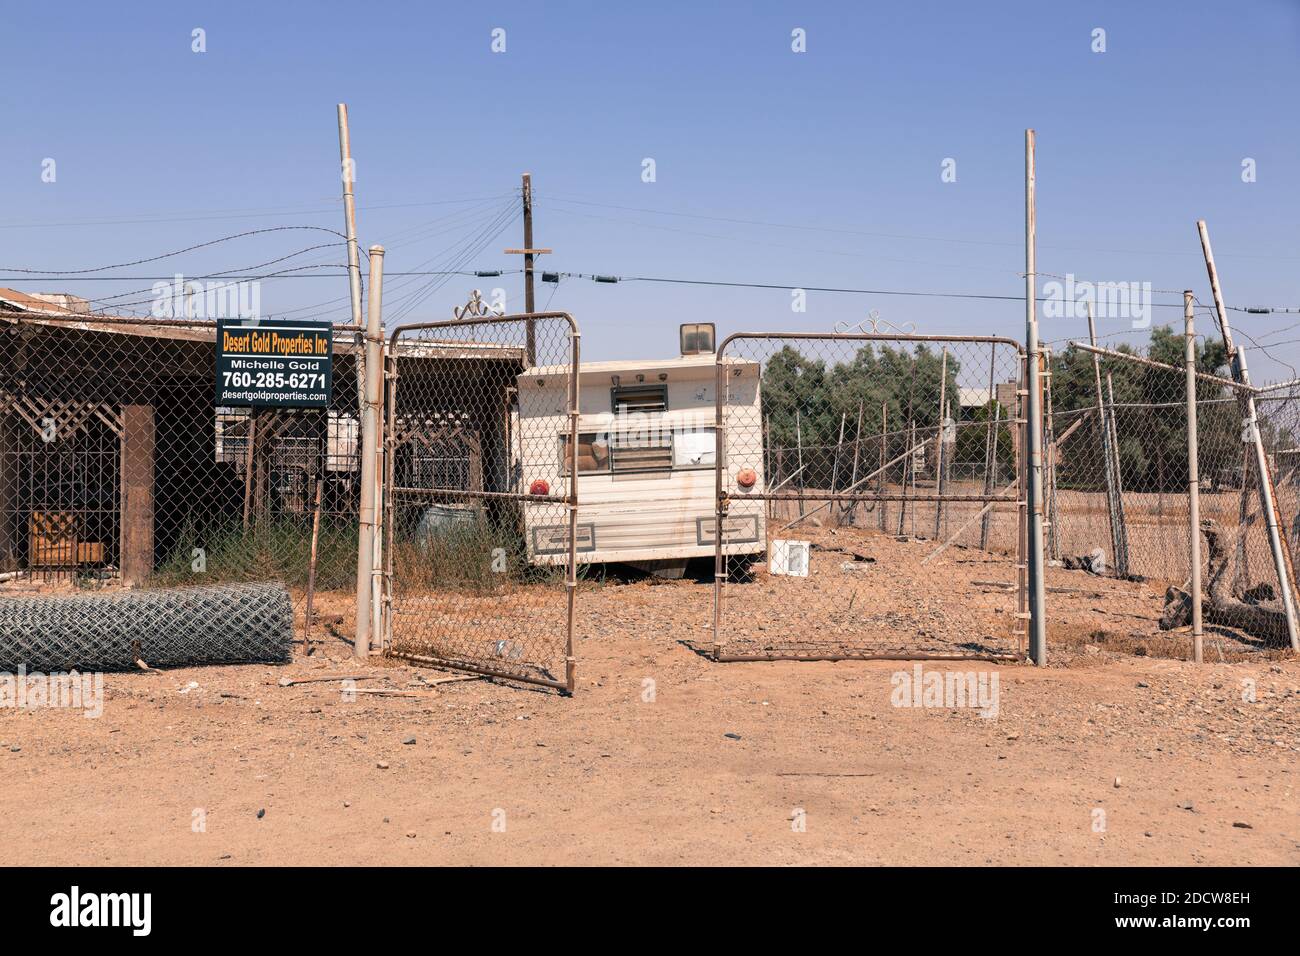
left=714, top=333, right=1024, bottom=659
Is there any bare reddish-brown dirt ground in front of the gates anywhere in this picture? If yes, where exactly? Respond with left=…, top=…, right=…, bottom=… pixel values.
left=0, top=538, right=1300, bottom=865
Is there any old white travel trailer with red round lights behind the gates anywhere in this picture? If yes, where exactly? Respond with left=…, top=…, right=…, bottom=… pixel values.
left=512, top=325, right=766, bottom=576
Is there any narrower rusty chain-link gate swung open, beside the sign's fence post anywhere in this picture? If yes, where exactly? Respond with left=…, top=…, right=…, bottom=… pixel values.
left=384, top=312, right=581, bottom=693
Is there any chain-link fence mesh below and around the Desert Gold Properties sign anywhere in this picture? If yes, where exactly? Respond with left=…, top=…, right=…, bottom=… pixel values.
left=0, top=315, right=359, bottom=655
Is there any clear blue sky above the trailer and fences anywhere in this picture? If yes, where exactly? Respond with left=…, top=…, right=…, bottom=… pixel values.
left=0, top=0, right=1300, bottom=380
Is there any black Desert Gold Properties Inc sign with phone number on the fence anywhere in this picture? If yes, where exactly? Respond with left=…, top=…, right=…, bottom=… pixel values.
left=216, top=319, right=334, bottom=408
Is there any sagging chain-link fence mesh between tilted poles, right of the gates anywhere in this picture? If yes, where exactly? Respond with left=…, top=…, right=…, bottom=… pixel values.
left=1044, top=343, right=1300, bottom=648
